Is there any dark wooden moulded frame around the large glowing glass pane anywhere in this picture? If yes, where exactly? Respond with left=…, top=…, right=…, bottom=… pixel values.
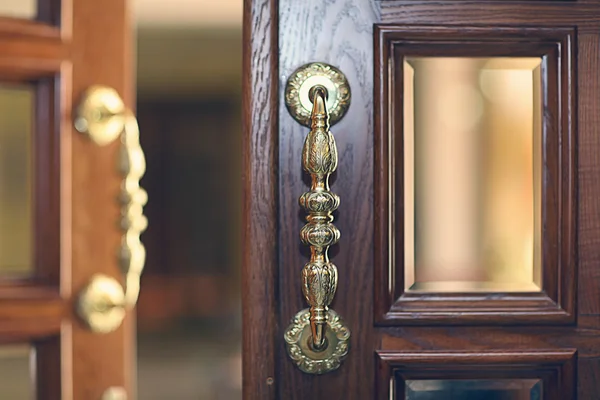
left=375, top=25, right=577, bottom=325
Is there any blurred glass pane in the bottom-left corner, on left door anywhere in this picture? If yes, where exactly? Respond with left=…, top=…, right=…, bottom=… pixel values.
left=0, top=345, right=35, bottom=400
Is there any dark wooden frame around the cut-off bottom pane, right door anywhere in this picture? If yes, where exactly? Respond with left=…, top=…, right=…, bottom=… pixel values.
left=375, top=349, right=577, bottom=400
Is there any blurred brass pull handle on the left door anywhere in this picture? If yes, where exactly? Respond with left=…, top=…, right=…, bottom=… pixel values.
left=75, top=86, right=148, bottom=333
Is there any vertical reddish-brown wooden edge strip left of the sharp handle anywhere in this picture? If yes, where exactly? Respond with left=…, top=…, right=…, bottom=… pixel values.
left=242, top=0, right=282, bottom=400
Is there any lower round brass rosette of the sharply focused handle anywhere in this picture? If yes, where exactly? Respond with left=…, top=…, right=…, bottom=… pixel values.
left=284, top=308, right=350, bottom=375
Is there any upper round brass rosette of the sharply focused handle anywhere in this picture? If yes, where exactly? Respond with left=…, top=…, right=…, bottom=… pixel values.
left=285, top=63, right=352, bottom=127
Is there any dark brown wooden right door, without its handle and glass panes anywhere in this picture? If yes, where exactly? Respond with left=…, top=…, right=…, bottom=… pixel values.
left=244, top=0, right=600, bottom=399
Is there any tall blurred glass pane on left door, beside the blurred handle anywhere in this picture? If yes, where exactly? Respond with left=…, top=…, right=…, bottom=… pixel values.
left=0, top=85, right=35, bottom=275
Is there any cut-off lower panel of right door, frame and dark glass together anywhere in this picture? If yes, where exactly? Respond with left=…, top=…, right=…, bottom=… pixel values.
left=376, top=350, right=575, bottom=400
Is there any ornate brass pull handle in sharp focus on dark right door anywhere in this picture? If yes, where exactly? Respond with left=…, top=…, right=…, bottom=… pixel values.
left=285, top=64, right=350, bottom=374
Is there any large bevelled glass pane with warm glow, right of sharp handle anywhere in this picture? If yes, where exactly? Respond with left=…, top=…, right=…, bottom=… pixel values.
left=404, top=57, right=542, bottom=292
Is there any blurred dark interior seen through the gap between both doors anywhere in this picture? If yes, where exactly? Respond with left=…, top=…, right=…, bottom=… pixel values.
left=134, top=0, right=242, bottom=400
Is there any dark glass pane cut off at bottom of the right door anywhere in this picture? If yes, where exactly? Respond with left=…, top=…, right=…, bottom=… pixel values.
left=405, top=379, right=542, bottom=400
